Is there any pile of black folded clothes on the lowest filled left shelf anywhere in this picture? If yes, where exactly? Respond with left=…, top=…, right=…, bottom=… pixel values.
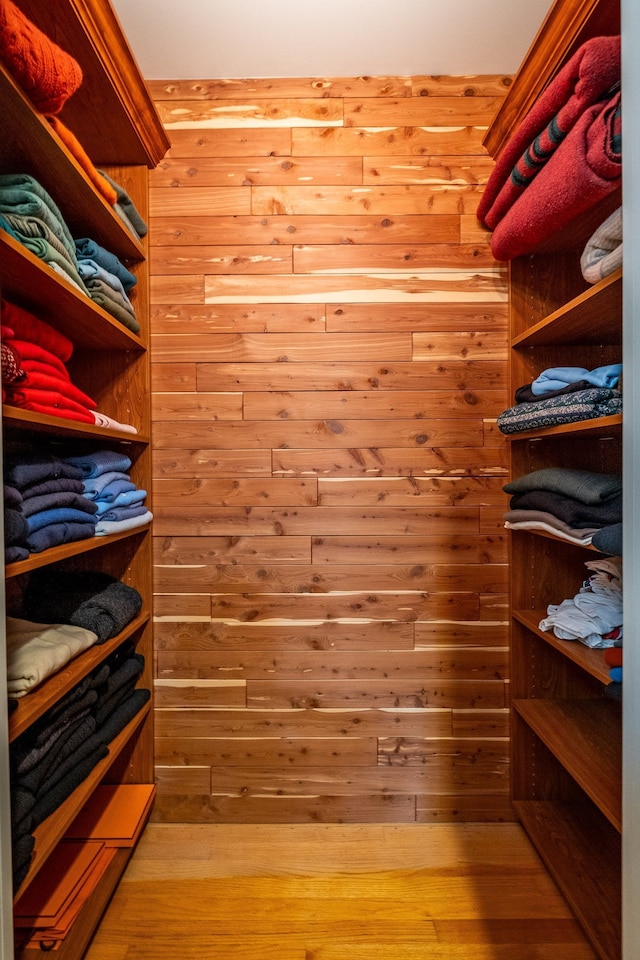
left=10, top=641, right=150, bottom=890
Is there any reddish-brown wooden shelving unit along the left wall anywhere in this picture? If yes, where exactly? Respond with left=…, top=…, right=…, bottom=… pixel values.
left=0, top=0, right=169, bottom=960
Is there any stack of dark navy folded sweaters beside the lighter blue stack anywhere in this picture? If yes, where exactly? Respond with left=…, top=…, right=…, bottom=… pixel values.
left=4, top=454, right=96, bottom=563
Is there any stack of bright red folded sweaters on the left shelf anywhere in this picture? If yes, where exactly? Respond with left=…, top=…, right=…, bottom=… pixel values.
left=2, top=301, right=96, bottom=424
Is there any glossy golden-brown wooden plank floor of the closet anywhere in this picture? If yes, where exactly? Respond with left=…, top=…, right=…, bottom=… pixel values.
left=86, top=823, right=595, bottom=960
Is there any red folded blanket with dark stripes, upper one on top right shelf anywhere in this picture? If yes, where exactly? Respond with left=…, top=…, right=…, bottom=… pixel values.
left=477, top=36, right=620, bottom=230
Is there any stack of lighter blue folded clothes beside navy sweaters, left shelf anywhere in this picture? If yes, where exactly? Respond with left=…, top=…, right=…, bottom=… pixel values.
left=66, top=450, right=153, bottom=536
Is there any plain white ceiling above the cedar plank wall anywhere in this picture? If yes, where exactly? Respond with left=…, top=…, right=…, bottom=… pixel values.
left=112, top=0, right=551, bottom=80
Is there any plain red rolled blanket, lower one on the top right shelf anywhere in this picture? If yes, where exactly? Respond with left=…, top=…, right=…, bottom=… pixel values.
left=491, top=93, right=622, bottom=260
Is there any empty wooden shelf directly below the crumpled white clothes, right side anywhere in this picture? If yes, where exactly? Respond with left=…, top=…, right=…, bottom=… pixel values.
left=513, top=699, right=622, bottom=831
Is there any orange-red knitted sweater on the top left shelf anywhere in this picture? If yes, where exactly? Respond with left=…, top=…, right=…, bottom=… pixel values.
left=0, top=0, right=82, bottom=114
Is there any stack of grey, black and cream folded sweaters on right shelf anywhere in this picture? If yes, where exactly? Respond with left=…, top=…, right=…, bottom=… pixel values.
left=503, top=467, right=622, bottom=556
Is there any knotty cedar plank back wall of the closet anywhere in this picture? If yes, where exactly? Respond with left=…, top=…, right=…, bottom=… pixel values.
left=150, top=77, right=512, bottom=823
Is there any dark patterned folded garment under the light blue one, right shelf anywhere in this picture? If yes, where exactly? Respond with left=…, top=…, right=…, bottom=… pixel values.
left=497, top=387, right=622, bottom=433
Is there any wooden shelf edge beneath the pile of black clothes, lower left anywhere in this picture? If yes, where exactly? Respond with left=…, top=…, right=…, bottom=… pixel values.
left=17, top=701, right=151, bottom=894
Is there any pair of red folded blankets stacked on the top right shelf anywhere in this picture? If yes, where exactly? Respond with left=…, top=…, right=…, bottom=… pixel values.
left=477, top=36, right=622, bottom=260
